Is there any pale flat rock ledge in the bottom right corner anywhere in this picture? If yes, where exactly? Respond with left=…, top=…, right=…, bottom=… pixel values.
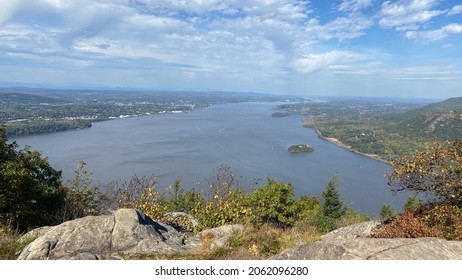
left=271, top=221, right=462, bottom=260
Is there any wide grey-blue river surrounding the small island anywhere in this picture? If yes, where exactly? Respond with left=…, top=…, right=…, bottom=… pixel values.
left=11, top=103, right=407, bottom=216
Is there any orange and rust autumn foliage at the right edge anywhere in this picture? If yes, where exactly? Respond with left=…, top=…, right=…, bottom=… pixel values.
left=374, top=140, right=462, bottom=240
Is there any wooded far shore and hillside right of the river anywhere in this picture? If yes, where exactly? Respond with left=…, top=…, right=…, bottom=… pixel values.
left=272, top=98, right=462, bottom=161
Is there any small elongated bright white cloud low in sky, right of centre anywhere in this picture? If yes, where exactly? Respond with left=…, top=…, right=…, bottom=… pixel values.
left=293, top=51, right=360, bottom=73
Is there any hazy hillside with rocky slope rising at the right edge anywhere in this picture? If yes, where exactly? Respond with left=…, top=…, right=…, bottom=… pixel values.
left=390, top=97, right=462, bottom=141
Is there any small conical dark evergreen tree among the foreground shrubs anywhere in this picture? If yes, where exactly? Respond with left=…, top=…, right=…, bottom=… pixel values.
left=321, top=176, right=346, bottom=219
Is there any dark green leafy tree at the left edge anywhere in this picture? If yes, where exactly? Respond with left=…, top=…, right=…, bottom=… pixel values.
left=0, top=126, right=65, bottom=231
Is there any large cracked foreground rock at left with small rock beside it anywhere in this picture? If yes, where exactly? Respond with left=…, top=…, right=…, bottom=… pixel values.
left=18, top=209, right=243, bottom=260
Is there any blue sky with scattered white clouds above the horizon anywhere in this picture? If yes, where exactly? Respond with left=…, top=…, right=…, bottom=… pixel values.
left=0, top=0, right=462, bottom=98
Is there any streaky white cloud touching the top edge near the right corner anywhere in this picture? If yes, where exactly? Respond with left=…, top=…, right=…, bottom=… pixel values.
left=379, top=0, right=445, bottom=31
